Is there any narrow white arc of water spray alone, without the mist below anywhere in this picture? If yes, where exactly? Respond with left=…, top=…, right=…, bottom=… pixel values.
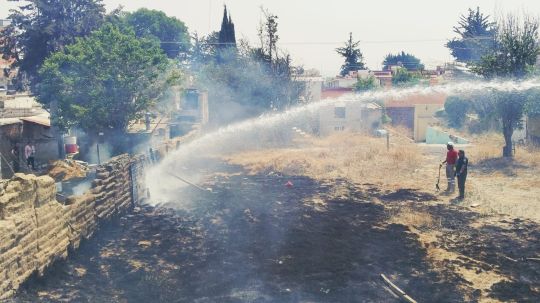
left=146, top=78, right=540, bottom=203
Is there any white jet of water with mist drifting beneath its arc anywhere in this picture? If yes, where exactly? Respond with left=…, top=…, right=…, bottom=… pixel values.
left=146, top=79, right=540, bottom=207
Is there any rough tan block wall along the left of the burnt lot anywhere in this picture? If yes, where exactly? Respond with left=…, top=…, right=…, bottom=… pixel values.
left=0, top=155, right=137, bottom=299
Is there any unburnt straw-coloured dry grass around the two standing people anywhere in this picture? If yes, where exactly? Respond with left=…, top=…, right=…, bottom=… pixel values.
left=228, top=134, right=540, bottom=302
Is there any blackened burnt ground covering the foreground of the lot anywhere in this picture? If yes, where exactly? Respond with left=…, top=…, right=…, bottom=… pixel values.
left=8, top=167, right=540, bottom=302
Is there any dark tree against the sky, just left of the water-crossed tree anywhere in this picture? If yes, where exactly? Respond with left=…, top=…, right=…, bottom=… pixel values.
left=446, top=7, right=495, bottom=63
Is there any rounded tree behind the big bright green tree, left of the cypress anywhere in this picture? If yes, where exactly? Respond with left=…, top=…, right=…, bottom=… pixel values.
left=125, top=8, right=191, bottom=59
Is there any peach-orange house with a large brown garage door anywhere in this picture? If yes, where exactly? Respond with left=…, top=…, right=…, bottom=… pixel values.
left=385, top=93, right=447, bottom=142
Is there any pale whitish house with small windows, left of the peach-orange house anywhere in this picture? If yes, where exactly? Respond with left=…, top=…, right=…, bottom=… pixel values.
left=318, top=100, right=382, bottom=136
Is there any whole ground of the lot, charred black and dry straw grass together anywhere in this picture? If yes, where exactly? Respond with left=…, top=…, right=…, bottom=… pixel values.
left=8, top=134, right=540, bottom=302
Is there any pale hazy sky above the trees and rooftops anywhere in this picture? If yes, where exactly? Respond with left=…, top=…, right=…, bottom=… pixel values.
left=0, top=0, right=540, bottom=76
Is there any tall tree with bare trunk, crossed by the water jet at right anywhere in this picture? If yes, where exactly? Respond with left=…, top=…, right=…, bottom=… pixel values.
left=471, top=16, right=540, bottom=157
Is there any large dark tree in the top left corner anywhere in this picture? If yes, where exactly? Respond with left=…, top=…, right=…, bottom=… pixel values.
left=0, top=0, right=105, bottom=85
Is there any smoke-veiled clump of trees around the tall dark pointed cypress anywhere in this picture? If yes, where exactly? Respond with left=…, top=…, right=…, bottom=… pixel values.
left=193, top=9, right=304, bottom=123
